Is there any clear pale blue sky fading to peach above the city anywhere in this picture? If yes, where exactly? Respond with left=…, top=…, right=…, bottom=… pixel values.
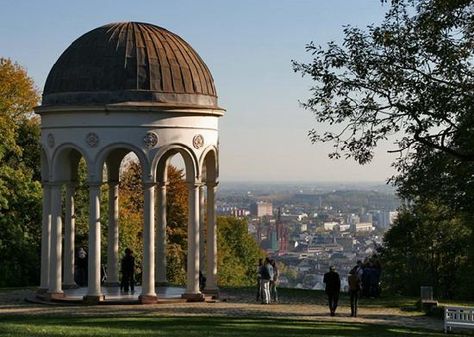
left=0, top=0, right=395, bottom=182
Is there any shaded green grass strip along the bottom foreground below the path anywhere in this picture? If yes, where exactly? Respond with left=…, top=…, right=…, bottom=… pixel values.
left=0, top=316, right=460, bottom=337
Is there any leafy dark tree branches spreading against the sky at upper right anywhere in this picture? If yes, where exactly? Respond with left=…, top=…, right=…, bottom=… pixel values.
left=293, top=0, right=474, bottom=164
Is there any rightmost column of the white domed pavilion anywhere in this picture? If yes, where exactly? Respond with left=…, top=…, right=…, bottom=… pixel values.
left=206, top=182, right=218, bottom=297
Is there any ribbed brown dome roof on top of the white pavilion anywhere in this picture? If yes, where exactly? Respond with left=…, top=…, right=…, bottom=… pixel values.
left=43, top=22, right=218, bottom=108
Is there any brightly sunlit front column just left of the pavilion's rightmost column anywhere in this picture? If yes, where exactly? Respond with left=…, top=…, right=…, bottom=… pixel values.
left=183, top=183, right=204, bottom=301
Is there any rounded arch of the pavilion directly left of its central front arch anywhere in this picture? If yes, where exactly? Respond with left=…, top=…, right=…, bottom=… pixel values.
left=49, top=143, right=92, bottom=181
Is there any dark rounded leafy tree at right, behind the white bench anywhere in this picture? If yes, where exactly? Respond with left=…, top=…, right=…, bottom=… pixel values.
left=380, top=203, right=474, bottom=298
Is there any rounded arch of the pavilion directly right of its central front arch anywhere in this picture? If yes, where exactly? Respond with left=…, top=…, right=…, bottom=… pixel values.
left=151, top=143, right=200, bottom=183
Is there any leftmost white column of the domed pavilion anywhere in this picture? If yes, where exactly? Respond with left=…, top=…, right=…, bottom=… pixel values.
left=38, top=182, right=51, bottom=293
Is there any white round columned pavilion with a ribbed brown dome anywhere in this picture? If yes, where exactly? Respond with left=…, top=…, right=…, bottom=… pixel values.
left=35, top=22, right=224, bottom=303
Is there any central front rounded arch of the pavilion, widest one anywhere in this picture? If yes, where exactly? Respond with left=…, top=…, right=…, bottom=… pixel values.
left=95, top=143, right=153, bottom=184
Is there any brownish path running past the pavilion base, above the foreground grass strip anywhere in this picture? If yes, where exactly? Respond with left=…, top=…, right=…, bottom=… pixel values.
left=0, top=290, right=443, bottom=331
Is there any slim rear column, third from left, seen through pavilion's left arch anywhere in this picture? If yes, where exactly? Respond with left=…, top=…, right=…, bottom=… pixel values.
left=63, top=183, right=77, bottom=289
